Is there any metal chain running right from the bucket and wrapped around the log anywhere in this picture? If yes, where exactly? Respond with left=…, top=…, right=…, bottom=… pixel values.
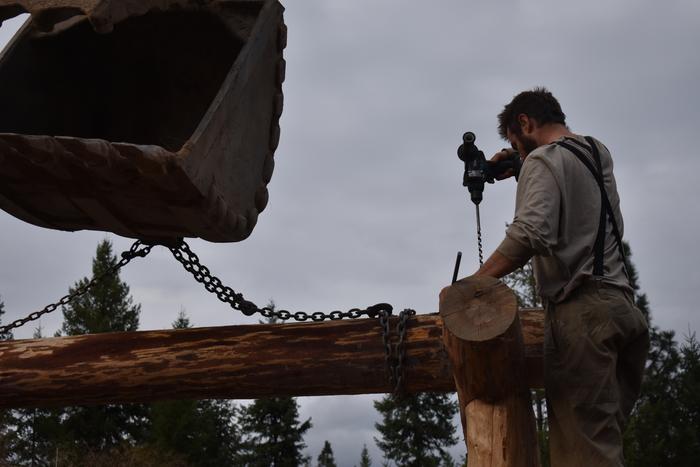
left=168, top=240, right=416, bottom=394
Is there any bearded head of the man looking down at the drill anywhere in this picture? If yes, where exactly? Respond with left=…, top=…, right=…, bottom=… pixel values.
left=498, top=87, right=568, bottom=156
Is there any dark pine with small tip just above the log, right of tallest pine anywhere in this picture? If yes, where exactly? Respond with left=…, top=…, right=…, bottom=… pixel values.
left=149, top=310, right=241, bottom=467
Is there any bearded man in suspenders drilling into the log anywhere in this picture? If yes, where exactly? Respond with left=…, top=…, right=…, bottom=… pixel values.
left=476, top=88, right=649, bottom=467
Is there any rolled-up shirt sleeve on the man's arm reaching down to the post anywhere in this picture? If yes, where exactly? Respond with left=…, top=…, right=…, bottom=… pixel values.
left=499, top=158, right=561, bottom=264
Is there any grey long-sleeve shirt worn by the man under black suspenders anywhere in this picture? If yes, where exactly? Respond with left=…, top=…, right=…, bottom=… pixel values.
left=497, top=135, right=632, bottom=302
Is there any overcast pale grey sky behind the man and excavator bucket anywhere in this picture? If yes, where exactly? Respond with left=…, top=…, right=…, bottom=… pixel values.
left=0, top=0, right=700, bottom=466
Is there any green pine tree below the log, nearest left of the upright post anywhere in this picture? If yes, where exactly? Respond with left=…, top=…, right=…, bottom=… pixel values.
left=374, top=393, right=458, bottom=467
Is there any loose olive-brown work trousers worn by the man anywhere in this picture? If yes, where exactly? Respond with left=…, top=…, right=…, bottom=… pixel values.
left=544, top=281, right=649, bottom=467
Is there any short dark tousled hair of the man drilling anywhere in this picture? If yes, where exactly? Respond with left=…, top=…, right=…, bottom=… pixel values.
left=498, top=87, right=566, bottom=139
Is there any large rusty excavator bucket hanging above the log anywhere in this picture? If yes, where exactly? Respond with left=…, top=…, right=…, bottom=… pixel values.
left=0, top=0, right=286, bottom=242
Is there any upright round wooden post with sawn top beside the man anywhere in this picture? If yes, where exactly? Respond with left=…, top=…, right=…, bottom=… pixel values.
left=440, top=277, right=540, bottom=467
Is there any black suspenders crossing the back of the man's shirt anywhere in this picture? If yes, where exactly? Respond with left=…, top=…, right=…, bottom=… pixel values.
left=557, top=136, right=625, bottom=277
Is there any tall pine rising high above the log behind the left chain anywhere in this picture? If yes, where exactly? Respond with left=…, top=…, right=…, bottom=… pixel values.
left=57, top=240, right=147, bottom=458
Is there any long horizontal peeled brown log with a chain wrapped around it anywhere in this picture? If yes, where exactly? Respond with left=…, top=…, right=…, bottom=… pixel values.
left=0, top=310, right=543, bottom=408
